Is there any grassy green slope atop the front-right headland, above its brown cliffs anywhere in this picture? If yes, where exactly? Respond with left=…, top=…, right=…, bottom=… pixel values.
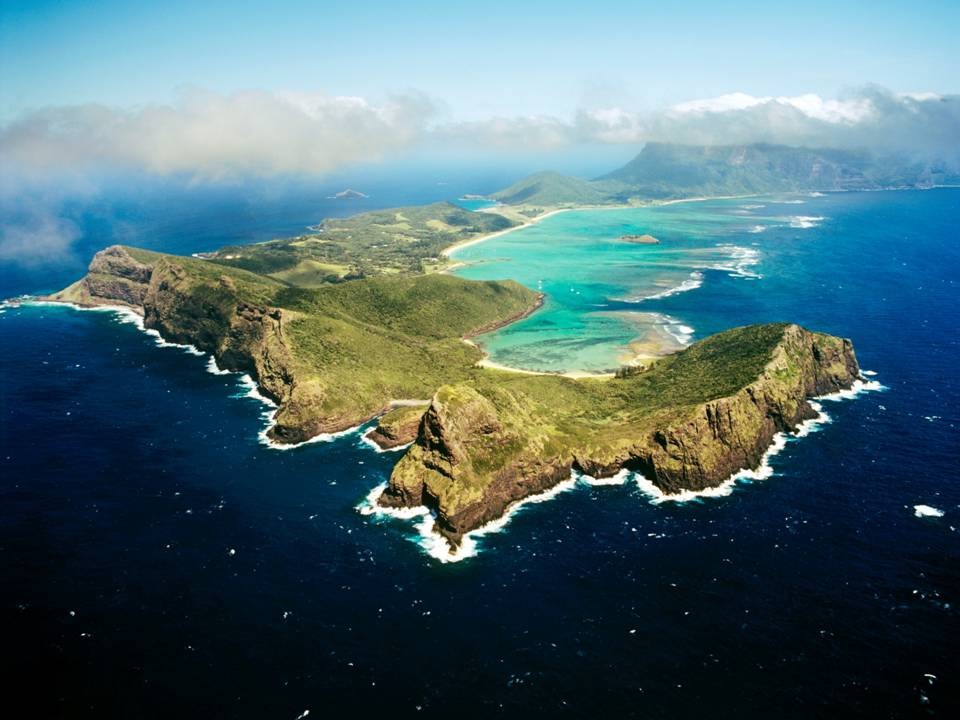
left=395, top=323, right=786, bottom=514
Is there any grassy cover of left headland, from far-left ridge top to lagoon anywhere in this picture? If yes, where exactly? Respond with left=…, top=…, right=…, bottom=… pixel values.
left=109, top=248, right=537, bottom=425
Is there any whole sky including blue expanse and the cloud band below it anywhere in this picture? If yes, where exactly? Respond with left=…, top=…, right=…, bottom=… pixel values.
left=0, top=0, right=960, bottom=183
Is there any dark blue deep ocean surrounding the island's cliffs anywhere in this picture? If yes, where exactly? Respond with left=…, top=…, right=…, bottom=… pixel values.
left=0, top=190, right=960, bottom=720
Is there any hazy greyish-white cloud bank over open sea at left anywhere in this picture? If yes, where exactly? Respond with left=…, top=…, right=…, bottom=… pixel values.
left=0, top=91, right=435, bottom=179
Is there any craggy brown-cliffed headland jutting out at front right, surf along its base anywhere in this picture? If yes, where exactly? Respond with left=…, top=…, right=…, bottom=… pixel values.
left=380, top=325, right=859, bottom=544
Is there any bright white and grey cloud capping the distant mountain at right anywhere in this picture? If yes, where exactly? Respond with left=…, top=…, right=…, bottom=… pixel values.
left=452, top=87, right=960, bottom=162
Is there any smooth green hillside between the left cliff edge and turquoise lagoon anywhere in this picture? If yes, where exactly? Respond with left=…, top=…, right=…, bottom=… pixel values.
left=276, top=275, right=536, bottom=416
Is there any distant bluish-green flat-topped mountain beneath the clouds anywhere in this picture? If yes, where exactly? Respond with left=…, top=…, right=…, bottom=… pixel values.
left=493, top=143, right=960, bottom=205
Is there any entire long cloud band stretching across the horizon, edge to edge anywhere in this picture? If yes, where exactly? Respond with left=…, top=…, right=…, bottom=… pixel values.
left=0, top=87, right=960, bottom=184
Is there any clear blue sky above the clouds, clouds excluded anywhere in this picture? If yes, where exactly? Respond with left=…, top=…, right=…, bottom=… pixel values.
left=0, top=0, right=960, bottom=121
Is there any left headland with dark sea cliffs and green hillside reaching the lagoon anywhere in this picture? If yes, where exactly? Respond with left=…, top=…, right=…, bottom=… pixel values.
left=48, top=246, right=541, bottom=445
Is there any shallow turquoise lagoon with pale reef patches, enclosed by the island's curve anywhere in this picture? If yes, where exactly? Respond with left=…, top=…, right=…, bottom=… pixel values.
left=453, top=197, right=823, bottom=371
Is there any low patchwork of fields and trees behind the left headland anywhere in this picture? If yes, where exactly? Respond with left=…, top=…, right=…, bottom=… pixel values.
left=211, top=202, right=517, bottom=287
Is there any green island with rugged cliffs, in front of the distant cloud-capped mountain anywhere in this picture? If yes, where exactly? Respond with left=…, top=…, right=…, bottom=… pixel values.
left=39, top=146, right=928, bottom=548
